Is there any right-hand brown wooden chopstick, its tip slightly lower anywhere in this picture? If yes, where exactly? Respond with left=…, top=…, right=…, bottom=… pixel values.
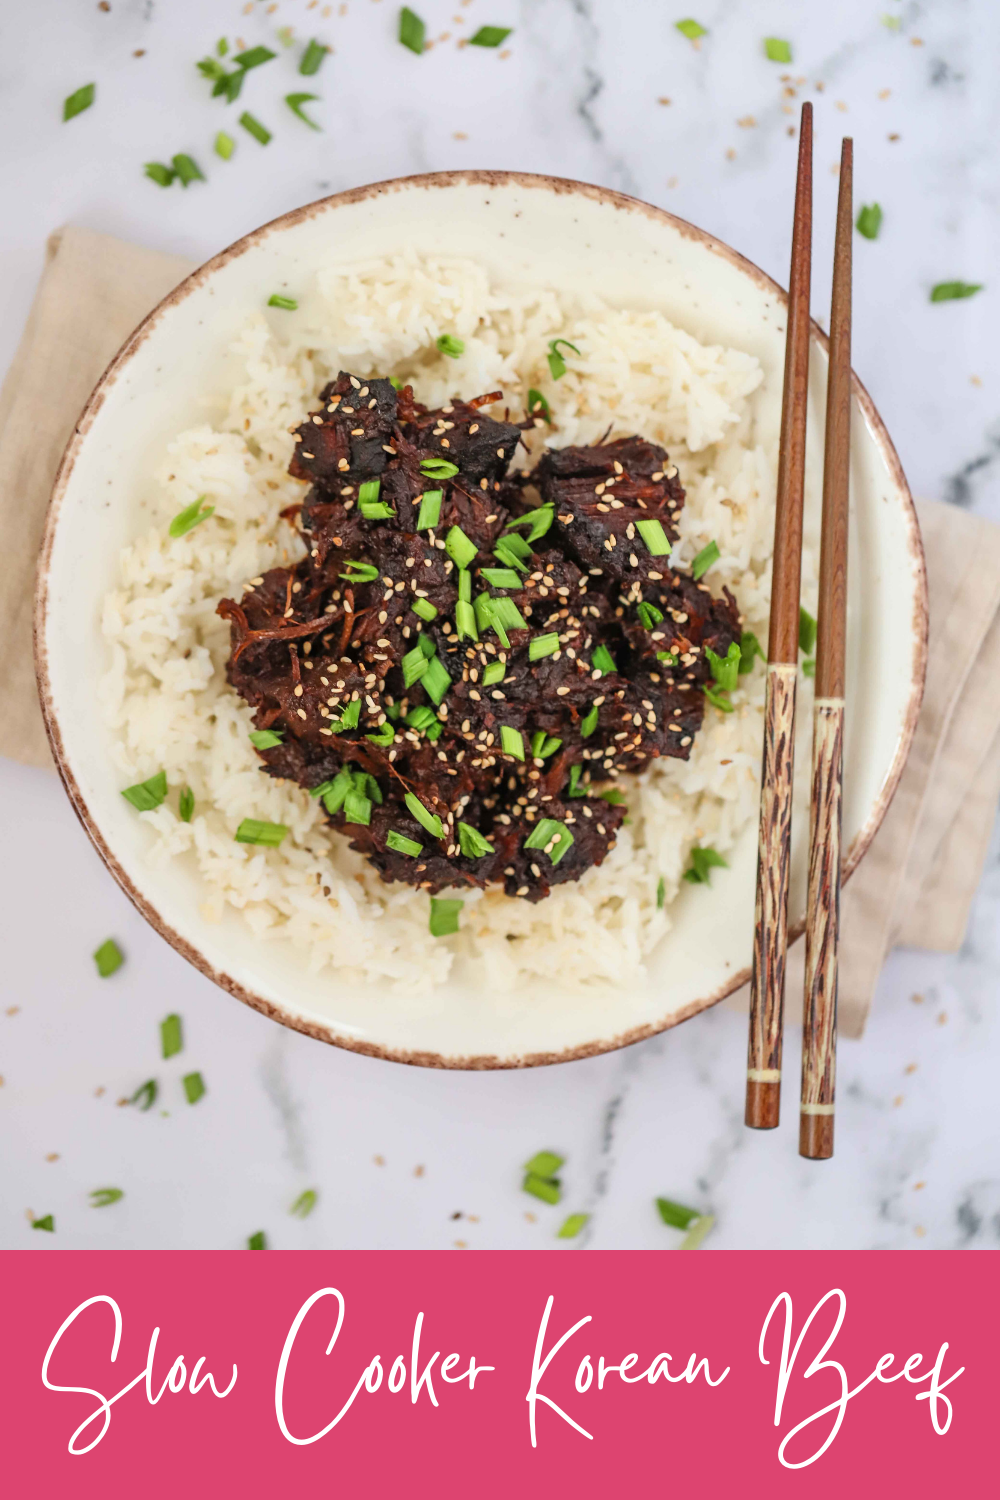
left=799, top=140, right=855, bottom=1161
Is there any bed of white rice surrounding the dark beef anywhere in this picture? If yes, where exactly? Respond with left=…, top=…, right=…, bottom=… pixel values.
left=102, top=255, right=816, bottom=993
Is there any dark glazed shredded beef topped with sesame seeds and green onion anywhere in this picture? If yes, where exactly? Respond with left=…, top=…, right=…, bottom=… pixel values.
left=219, top=372, right=741, bottom=902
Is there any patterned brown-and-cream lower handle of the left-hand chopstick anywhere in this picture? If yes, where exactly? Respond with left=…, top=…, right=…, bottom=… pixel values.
left=745, top=662, right=796, bottom=1130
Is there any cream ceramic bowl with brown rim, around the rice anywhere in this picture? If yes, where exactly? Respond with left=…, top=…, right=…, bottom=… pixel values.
left=36, top=173, right=927, bottom=1068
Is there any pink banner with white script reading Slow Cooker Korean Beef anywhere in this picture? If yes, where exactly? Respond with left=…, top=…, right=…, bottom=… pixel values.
left=0, top=1251, right=983, bottom=1500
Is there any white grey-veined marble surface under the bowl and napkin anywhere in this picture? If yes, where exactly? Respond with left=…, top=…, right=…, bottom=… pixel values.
left=0, top=0, right=1000, bottom=1248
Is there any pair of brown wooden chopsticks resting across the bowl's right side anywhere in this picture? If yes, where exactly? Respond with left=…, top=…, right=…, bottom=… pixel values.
left=745, top=104, right=853, bottom=1160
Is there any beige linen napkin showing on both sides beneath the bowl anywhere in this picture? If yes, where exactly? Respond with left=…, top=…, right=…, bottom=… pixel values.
left=0, top=228, right=1000, bottom=1037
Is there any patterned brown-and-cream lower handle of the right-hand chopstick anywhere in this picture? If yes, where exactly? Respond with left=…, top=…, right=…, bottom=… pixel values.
left=799, top=698, right=844, bottom=1160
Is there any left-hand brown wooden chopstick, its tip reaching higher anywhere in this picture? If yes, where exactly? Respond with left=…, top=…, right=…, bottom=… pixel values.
left=745, top=104, right=813, bottom=1130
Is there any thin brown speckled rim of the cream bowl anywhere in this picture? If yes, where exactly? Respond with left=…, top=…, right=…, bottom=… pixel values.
left=33, top=168, right=928, bottom=1071
